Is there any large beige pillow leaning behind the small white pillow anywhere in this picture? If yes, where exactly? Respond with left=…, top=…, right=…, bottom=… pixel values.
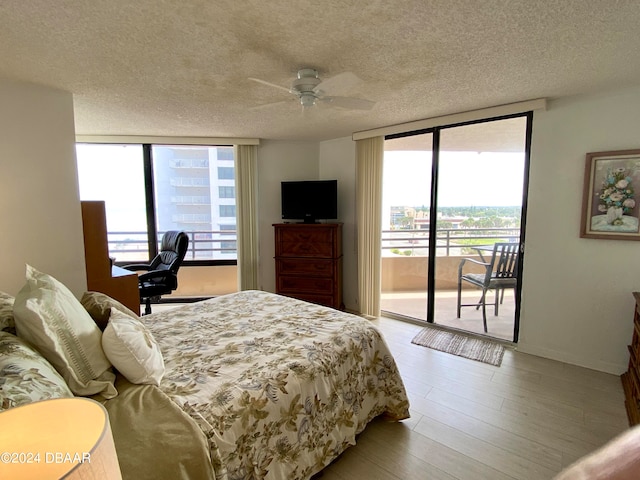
left=13, top=265, right=118, bottom=398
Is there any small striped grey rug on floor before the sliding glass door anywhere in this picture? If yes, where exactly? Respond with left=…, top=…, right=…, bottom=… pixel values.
left=411, top=327, right=504, bottom=367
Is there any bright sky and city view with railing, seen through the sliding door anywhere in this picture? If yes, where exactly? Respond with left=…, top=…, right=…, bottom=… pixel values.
left=382, top=150, right=524, bottom=256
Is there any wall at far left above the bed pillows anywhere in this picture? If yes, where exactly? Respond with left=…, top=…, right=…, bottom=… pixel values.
left=0, top=79, right=87, bottom=295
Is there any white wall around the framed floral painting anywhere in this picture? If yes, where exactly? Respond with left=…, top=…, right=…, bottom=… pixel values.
left=519, top=88, right=640, bottom=374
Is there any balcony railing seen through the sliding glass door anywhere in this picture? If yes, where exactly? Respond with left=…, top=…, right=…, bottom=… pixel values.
left=382, top=227, right=520, bottom=257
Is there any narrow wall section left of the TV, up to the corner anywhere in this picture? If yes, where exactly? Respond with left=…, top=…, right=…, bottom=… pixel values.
left=258, top=137, right=319, bottom=292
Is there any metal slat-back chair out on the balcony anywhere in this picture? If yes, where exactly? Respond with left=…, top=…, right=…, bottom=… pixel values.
left=458, top=243, right=520, bottom=333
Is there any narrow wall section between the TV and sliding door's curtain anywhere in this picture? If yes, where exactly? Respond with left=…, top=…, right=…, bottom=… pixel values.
left=320, top=137, right=360, bottom=312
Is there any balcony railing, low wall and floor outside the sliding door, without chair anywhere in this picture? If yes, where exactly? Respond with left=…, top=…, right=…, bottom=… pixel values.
left=381, top=228, right=520, bottom=341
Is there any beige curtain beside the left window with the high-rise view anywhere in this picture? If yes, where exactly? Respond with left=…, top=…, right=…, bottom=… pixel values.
left=234, top=145, right=259, bottom=290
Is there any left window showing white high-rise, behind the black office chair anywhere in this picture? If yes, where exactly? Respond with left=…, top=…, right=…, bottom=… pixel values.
left=76, top=144, right=237, bottom=264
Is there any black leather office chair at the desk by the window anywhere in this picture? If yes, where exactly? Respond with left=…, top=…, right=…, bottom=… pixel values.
left=123, top=230, right=189, bottom=315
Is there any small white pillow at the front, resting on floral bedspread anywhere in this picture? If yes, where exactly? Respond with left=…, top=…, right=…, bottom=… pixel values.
left=102, top=308, right=164, bottom=385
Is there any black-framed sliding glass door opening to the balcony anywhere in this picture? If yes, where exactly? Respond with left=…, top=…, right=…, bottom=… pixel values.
left=381, top=114, right=532, bottom=341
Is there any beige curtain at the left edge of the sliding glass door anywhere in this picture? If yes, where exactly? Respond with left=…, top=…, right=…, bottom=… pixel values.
left=356, top=137, right=384, bottom=317
